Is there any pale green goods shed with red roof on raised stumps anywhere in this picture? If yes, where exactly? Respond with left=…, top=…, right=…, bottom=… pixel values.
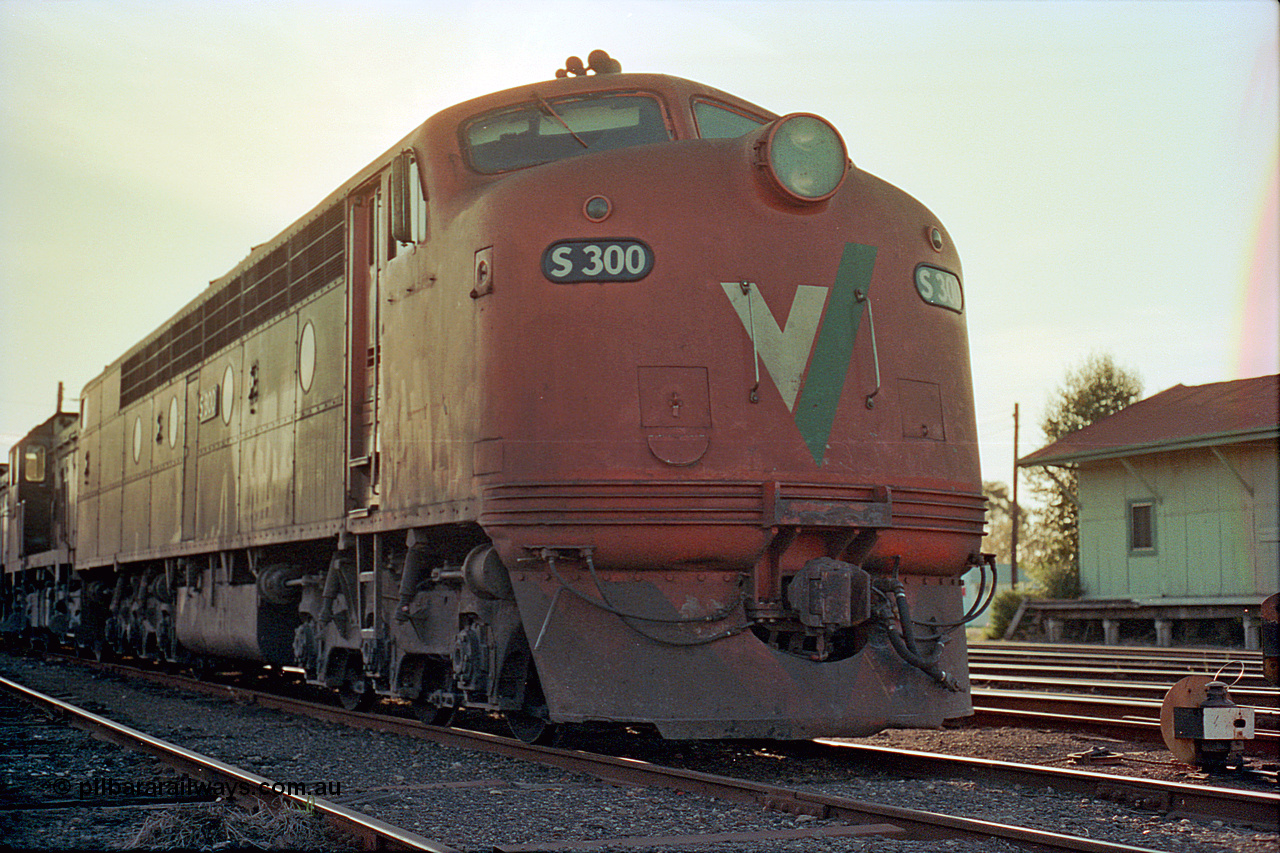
left=1018, top=375, right=1280, bottom=648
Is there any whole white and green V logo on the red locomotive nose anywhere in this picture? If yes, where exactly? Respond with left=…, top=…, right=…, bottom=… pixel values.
left=721, top=243, right=876, bottom=465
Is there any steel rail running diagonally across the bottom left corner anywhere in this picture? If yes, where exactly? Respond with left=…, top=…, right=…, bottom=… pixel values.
left=0, top=678, right=457, bottom=853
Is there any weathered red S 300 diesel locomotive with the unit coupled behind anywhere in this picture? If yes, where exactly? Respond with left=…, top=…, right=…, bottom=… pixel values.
left=0, top=51, right=993, bottom=740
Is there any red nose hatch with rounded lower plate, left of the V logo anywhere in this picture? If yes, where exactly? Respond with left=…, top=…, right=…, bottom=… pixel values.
left=636, top=366, right=712, bottom=465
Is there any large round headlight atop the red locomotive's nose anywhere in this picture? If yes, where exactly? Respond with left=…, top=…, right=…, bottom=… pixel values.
left=763, top=113, right=849, bottom=202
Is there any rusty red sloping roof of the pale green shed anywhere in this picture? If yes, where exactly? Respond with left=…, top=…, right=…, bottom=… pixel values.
left=1018, top=374, right=1280, bottom=466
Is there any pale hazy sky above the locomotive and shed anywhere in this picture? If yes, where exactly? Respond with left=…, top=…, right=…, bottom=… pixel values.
left=0, top=0, right=1280, bottom=482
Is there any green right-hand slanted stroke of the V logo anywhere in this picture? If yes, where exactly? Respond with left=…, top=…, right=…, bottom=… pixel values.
left=795, top=243, right=876, bottom=465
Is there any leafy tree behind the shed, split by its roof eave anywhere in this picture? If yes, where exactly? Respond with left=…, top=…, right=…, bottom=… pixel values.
left=1028, top=353, right=1142, bottom=597
